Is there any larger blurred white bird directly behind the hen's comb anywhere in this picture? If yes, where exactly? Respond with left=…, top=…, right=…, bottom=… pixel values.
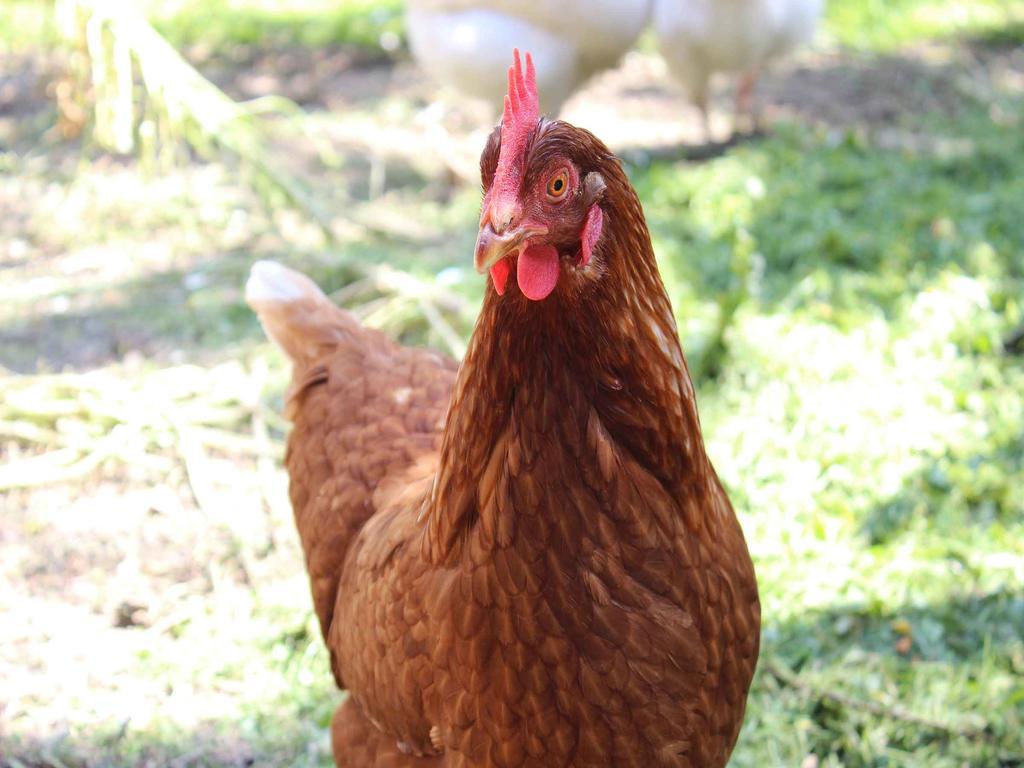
left=407, top=0, right=652, bottom=117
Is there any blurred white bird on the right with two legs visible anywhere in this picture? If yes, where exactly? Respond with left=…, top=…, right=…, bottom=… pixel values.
left=653, top=0, right=823, bottom=140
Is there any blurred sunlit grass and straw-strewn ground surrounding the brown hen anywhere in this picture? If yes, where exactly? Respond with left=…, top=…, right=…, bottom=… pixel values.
left=0, top=0, right=1024, bottom=768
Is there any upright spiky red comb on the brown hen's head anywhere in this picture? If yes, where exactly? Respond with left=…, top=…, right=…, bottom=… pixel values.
left=488, top=48, right=541, bottom=225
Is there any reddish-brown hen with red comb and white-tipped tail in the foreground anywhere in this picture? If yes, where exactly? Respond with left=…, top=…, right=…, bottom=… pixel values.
left=247, top=54, right=760, bottom=768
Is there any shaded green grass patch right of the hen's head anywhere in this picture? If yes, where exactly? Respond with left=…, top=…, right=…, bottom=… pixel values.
left=634, top=99, right=1024, bottom=311
